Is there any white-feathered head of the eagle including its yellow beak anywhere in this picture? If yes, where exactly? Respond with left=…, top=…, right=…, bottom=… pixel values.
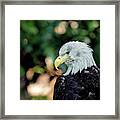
left=54, top=41, right=96, bottom=76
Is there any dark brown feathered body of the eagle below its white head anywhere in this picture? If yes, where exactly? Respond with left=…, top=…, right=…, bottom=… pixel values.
left=53, top=66, right=100, bottom=100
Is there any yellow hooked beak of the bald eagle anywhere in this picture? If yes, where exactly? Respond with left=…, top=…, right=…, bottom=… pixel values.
left=54, top=54, right=70, bottom=70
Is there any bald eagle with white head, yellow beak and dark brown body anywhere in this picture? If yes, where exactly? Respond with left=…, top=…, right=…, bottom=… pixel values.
left=53, top=41, right=100, bottom=100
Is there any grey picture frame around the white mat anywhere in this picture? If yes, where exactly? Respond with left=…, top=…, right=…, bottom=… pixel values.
left=0, top=0, right=120, bottom=119
